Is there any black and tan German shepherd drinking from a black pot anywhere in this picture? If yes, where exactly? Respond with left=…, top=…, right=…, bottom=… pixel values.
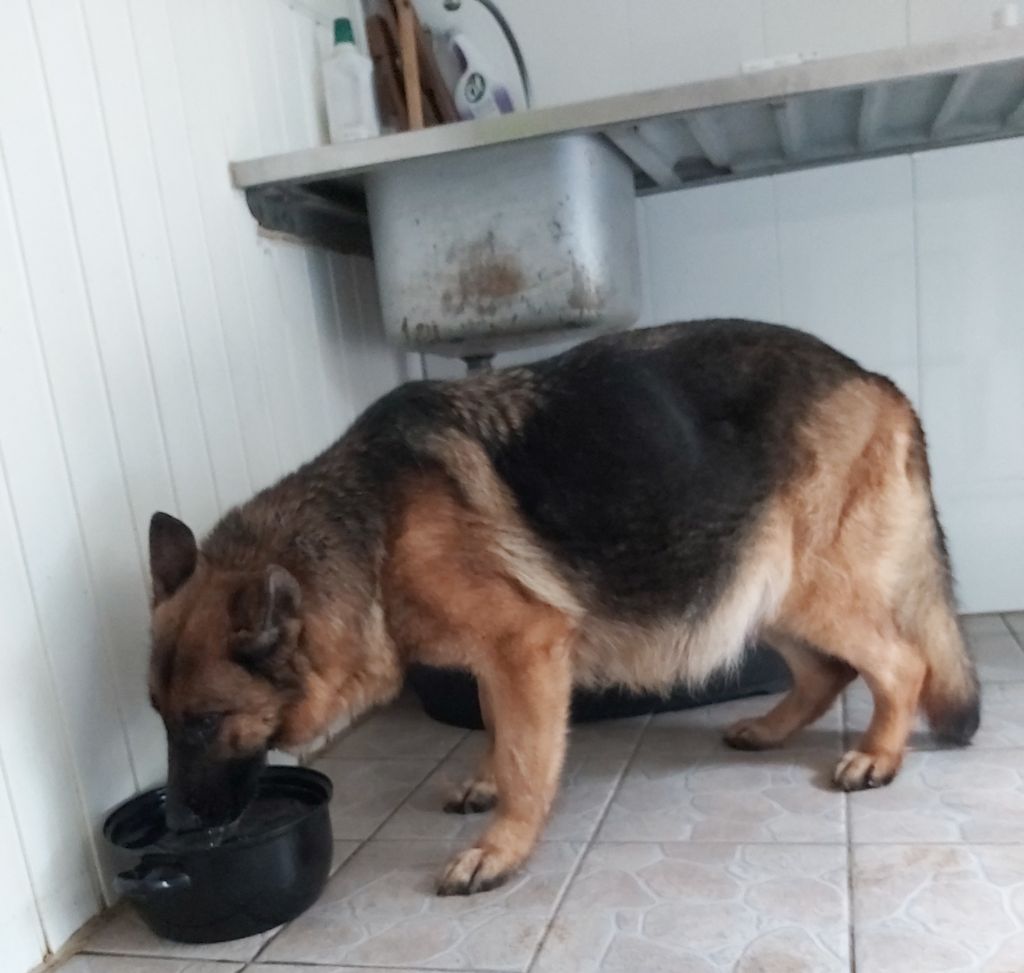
left=150, top=321, right=980, bottom=894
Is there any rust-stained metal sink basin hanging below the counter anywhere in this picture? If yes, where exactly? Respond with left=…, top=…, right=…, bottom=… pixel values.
left=366, top=134, right=640, bottom=357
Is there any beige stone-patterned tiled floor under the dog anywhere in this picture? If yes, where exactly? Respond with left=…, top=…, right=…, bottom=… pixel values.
left=62, top=614, right=1024, bottom=973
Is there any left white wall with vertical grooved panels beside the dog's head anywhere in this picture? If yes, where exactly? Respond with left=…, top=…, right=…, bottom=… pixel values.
left=0, top=0, right=407, bottom=973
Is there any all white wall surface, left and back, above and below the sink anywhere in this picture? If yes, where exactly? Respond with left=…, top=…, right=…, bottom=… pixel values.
left=0, top=0, right=1024, bottom=973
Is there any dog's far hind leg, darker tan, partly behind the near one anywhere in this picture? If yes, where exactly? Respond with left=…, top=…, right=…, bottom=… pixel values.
left=725, top=634, right=857, bottom=750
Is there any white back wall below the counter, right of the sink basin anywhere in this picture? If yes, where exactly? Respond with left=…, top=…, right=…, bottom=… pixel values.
left=642, top=138, right=1024, bottom=611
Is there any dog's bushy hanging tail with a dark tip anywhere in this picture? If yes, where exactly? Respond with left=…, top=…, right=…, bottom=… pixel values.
left=901, top=417, right=981, bottom=747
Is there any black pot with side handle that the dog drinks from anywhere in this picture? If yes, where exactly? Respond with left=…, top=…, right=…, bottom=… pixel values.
left=103, top=767, right=333, bottom=942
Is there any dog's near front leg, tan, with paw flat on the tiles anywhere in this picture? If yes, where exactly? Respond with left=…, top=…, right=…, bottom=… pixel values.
left=438, top=639, right=571, bottom=895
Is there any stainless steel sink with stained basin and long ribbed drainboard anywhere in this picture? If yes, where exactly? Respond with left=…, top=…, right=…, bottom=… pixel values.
left=231, top=28, right=1024, bottom=358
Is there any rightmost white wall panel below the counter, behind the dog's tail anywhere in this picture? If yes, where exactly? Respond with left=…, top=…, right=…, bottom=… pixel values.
left=914, top=138, right=1024, bottom=608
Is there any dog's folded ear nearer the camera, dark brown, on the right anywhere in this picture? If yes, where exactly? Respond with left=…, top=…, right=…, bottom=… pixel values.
left=230, top=564, right=302, bottom=675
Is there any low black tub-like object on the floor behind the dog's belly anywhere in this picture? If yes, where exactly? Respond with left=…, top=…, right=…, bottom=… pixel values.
left=408, top=646, right=790, bottom=729
